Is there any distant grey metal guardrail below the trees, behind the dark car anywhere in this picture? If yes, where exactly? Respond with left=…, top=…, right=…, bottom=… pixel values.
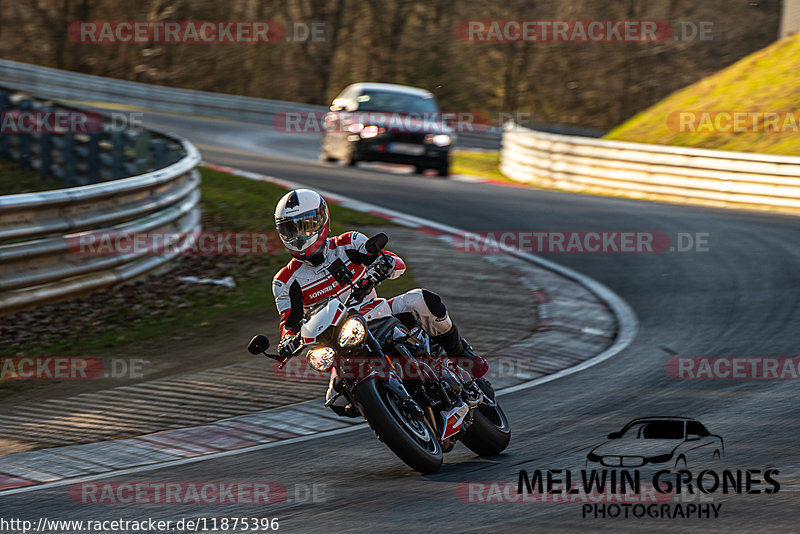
left=0, top=60, right=502, bottom=150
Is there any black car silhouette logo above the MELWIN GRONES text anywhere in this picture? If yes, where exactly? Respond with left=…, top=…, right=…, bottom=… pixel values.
left=586, top=417, right=724, bottom=468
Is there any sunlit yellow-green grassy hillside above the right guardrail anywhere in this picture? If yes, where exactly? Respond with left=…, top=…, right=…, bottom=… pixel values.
left=606, top=35, right=800, bottom=155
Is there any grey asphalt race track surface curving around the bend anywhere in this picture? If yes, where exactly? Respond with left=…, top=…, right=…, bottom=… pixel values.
left=0, top=113, right=800, bottom=532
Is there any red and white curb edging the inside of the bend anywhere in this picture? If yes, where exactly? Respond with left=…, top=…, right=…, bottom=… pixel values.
left=0, top=164, right=637, bottom=496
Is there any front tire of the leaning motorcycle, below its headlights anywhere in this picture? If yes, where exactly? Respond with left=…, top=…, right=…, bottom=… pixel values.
left=354, top=380, right=443, bottom=474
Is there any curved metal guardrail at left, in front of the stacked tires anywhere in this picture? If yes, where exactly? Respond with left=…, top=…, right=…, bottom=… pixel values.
left=0, top=89, right=200, bottom=314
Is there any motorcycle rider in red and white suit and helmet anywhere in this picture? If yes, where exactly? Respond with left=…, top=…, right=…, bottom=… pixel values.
left=272, top=189, right=489, bottom=415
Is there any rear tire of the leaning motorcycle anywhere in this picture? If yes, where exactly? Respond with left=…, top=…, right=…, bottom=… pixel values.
left=461, top=378, right=511, bottom=456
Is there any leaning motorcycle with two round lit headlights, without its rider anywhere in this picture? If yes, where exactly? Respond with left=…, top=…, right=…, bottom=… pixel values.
left=248, top=233, right=511, bottom=474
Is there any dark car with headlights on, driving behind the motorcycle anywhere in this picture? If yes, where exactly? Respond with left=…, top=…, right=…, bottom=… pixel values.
left=320, top=83, right=454, bottom=176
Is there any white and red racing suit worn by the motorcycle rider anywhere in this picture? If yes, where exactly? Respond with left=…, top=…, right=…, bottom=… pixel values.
left=272, top=232, right=460, bottom=344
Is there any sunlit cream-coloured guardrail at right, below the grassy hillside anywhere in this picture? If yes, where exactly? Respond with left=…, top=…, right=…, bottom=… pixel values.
left=500, top=123, right=800, bottom=209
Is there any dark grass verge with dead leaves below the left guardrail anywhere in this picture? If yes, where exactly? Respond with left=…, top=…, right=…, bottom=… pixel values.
left=0, top=168, right=416, bottom=397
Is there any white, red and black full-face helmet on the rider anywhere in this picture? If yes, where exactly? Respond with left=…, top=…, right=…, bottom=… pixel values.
left=275, top=189, right=330, bottom=261
